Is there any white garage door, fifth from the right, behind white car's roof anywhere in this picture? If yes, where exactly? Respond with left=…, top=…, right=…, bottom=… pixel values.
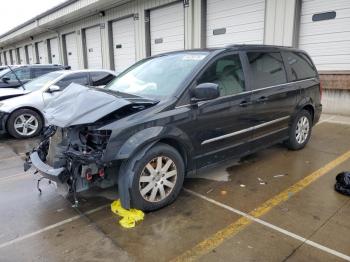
left=85, top=26, right=102, bottom=69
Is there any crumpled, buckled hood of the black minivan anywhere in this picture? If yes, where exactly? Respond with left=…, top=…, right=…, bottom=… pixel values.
left=43, top=83, right=132, bottom=128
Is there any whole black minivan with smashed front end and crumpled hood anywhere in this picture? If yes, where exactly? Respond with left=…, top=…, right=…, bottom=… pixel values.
left=25, top=45, right=322, bottom=211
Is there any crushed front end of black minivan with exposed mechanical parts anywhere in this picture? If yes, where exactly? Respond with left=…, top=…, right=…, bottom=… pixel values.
left=24, top=125, right=116, bottom=204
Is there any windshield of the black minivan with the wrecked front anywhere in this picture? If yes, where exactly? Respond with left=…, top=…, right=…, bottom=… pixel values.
left=106, top=52, right=209, bottom=100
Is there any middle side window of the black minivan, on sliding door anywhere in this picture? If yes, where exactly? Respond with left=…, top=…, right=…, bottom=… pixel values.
left=247, top=52, right=287, bottom=89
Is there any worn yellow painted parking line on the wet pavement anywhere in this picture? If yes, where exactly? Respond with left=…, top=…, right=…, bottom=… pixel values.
left=172, top=151, right=350, bottom=261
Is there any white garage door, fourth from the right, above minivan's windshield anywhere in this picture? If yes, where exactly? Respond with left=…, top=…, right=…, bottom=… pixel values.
left=112, top=17, right=136, bottom=72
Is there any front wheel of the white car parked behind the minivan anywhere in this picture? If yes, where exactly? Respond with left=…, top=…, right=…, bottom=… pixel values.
left=7, top=109, right=43, bottom=138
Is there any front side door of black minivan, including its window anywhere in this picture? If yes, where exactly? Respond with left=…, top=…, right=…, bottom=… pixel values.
left=192, top=53, right=253, bottom=168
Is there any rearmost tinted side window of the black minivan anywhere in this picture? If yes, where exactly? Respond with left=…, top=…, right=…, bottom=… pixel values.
left=285, top=52, right=317, bottom=81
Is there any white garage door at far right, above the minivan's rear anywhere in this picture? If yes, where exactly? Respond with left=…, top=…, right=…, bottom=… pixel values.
left=299, top=0, right=350, bottom=70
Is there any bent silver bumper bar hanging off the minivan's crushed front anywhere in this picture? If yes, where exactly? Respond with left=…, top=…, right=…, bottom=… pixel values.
left=24, top=151, right=66, bottom=183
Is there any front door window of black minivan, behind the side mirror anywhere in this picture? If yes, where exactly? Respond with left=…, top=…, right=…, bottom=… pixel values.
left=198, top=54, right=245, bottom=96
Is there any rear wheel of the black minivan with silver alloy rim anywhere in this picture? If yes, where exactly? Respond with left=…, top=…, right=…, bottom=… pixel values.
left=286, top=109, right=312, bottom=150
